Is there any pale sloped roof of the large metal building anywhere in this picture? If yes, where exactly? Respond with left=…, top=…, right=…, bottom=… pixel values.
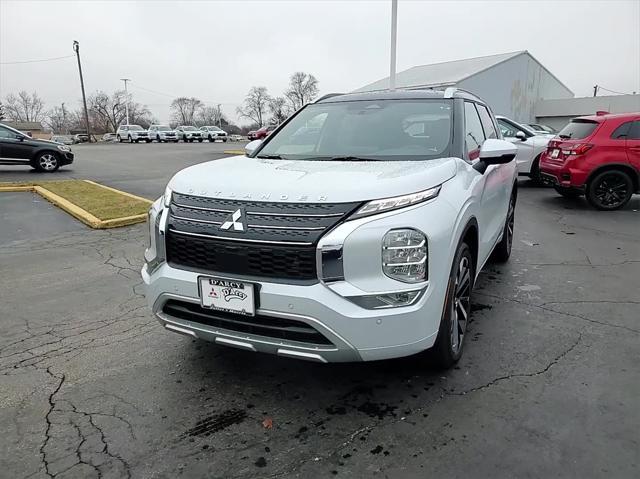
left=355, top=50, right=528, bottom=92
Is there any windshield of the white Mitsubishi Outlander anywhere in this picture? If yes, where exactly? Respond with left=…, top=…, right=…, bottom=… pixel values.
left=257, top=99, right=452, bottom=160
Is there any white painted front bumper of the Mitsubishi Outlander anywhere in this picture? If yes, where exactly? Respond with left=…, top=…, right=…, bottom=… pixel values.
left=142, top=195, right=455, bottom=362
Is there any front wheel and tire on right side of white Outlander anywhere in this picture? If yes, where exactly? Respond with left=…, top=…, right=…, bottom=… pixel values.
left=430, top=242, right=475, bottom=369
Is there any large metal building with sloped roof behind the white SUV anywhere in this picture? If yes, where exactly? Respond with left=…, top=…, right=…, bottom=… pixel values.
left=355, top=50, right=573, bottom=123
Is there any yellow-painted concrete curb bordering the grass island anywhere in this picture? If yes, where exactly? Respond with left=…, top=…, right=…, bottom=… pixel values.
left=0, top=180, right=153, bottom=229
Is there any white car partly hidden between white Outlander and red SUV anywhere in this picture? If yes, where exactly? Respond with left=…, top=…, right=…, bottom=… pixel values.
left=496, top=115, right=553, bottom=184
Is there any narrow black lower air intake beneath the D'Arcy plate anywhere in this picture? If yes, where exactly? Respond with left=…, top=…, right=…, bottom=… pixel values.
left=162, top=300, right=332, bottom=345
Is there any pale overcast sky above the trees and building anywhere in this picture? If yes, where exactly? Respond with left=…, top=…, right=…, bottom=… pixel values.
left=0, top=0, right=640, bottom=122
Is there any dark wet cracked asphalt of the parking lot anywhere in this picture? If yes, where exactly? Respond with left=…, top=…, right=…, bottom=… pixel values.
left=0, top=143, right=640, bottom=478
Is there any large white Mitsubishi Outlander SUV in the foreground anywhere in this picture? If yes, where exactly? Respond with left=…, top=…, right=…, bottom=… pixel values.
left=142, top=89, right=517, bottom=367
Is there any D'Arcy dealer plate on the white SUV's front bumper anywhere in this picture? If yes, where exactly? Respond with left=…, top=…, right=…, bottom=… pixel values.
left=199, top=277, right=256, bottom=316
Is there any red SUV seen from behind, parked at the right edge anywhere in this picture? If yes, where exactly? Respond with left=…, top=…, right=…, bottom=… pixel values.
left=540, top=113, right=640, bottom=210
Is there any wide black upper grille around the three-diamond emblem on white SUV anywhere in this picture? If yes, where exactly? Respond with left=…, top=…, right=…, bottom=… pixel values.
left=166, top=193, right=360, bottom=280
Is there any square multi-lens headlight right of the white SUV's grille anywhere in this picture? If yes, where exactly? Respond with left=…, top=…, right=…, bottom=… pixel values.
left=382, top=229, right=427, bottom=283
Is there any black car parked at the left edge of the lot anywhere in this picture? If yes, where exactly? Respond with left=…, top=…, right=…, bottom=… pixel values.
left=0, top=123, right=73, bottom=172
